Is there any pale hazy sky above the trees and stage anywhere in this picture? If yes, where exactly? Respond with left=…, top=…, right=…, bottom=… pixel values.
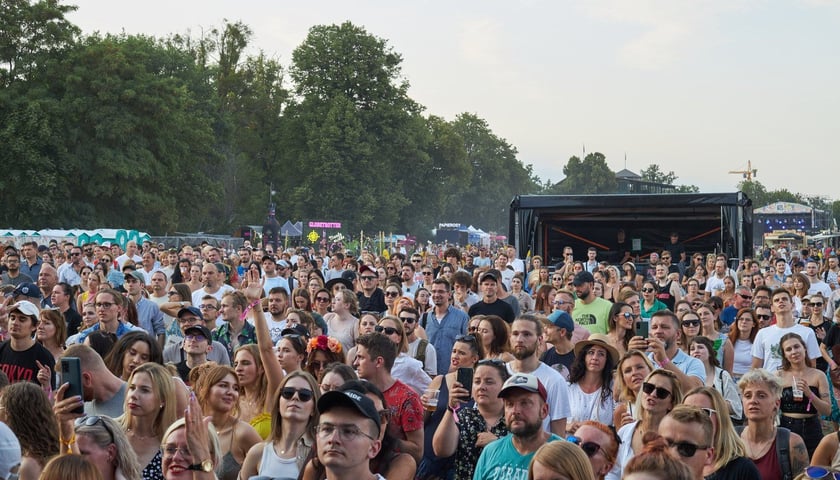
left=65, top=0, right=840, bottom=200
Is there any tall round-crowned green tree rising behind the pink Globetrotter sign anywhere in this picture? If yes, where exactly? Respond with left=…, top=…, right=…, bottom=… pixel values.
left=274, top=22, right=427, bottom=232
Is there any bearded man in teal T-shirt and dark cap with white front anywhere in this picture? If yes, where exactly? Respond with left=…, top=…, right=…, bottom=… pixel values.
left=473, top=373, right=561, bottom=480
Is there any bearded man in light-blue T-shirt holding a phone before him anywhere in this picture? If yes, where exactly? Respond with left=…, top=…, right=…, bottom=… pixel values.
left=627, top=310, right=706, bottom=392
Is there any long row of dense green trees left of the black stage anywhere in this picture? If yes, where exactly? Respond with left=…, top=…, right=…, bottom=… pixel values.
left=0, top=0, right=540, bottom=237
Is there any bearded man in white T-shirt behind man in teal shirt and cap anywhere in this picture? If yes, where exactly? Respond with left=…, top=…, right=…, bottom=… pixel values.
left=507, top=315, right=570, bottom=435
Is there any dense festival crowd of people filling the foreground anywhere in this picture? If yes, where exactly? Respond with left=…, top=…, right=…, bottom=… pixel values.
left=0, top=237, right=840, bottom=480
